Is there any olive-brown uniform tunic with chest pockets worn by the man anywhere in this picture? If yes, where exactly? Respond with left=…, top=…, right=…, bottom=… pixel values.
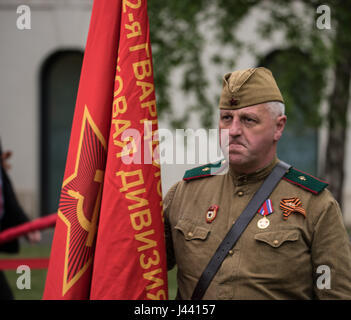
left=164, top=159, right=351, bottom=299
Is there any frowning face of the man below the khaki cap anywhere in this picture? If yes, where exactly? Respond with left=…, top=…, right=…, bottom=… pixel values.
left=219, top=104, right=286, bottom=173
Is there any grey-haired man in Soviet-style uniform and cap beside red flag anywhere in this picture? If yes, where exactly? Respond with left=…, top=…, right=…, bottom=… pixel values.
left=164, top=68, right=351, bottom=299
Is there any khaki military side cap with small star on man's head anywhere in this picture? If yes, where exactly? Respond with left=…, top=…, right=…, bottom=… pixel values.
left=219, top=67, right=284, bottom=110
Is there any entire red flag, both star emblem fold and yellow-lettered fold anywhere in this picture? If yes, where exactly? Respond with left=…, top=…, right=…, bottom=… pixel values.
left=44, top=0, right=167, bottom=299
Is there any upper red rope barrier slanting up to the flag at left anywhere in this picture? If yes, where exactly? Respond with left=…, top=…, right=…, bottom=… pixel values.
left=0, top=213, right=57, bottom=244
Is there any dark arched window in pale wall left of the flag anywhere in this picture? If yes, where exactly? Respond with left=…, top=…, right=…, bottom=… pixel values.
left=40, top=51, right=83, bottom=215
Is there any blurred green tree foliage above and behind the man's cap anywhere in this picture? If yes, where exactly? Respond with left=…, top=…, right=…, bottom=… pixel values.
left=149, top=0, right=331, bottom=127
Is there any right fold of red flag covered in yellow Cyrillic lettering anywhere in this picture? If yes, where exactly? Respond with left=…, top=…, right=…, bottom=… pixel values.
left=91, top=0, right=168, bottom=299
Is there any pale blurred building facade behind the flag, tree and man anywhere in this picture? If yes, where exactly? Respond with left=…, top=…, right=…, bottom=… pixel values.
left=0, top=0, right=351, bottom=226
